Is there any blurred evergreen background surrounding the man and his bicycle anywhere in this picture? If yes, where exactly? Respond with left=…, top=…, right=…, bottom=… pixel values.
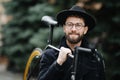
left=0, top=0, right=120, bottom=80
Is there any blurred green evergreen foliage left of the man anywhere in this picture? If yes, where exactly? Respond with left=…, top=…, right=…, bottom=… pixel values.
left=2, top=0, right=76, bottom=71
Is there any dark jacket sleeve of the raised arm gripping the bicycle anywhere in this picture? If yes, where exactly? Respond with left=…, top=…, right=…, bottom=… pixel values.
left=38, top=50, right=61, bottom=80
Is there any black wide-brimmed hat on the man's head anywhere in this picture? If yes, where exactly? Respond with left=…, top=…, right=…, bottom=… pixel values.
left=57, top=5, right=96, bottom=30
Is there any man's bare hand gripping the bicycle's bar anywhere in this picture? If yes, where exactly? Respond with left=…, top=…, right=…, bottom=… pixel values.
left=57, top=47, right=72, bottom=65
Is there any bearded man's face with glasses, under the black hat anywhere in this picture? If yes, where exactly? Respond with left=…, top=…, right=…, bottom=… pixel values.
left=63, top=16, right=88, bottom=44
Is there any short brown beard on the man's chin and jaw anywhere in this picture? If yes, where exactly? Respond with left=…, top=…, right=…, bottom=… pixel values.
left=65, top=34, right=84, bottom=44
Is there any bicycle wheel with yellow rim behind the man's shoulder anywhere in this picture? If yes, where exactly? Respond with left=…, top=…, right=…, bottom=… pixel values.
left=23, top=48, right=42, bottom=80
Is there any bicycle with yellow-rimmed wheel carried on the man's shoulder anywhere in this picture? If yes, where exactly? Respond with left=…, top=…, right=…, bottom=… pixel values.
left=23, top=16, right=104, bottom=80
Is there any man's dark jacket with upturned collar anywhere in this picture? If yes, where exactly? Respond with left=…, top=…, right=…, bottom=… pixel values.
left=38, top=38, right=105, bottom=80
